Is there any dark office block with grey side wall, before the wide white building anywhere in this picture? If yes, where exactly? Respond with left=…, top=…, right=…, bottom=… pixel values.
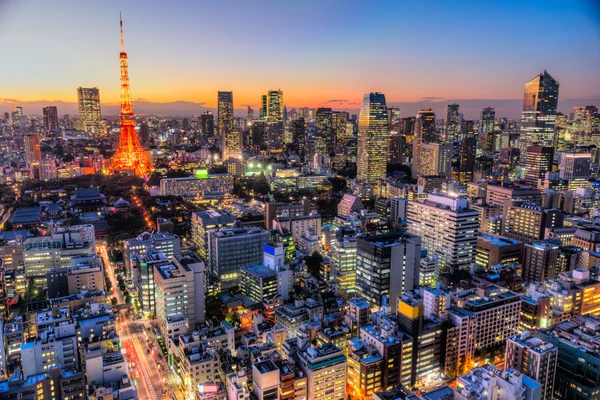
left=356, top=232, right=421, bottom=312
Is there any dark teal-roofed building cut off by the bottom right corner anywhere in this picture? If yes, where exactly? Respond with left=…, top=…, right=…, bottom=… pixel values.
left=536, top=315, right=600, bottom=399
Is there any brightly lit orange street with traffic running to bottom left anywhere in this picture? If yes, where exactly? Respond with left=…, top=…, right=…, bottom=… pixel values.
left=97, top=243, right=185, bottom=400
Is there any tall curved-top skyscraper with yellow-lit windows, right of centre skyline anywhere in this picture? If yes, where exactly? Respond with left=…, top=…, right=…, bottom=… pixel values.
left=356, top=93, right=388, bottom=183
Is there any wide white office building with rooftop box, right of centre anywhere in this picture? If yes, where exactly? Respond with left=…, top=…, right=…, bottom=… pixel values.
left=406, top=194, right=479, bottom=279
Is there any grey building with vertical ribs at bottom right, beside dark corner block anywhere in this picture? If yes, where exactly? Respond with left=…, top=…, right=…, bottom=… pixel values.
left=504, top=331, right=558, bottom=400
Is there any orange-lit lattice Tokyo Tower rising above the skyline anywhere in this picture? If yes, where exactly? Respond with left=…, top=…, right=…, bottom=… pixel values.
left=108, top=14, right=153, bottom=177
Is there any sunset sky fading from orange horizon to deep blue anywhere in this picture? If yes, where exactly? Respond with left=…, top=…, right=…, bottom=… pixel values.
left=0, top=0, right=600, bottom=112
